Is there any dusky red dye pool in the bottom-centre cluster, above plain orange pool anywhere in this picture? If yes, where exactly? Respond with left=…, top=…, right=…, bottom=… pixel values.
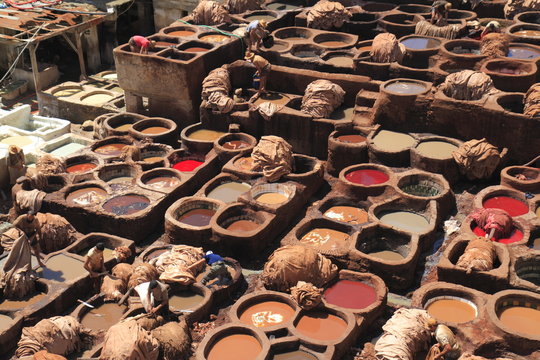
left=324, top=280, right=377, bottom=309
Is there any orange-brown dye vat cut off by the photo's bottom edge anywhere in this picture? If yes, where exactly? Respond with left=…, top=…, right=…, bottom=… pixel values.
left=207, top=334, right=262, bottom=360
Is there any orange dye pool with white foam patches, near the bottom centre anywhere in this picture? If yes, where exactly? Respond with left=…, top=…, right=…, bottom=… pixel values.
left=240, top=301, right=294, bottom=327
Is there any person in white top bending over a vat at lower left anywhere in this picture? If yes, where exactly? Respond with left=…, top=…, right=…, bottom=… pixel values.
left=118, top=280, right=169, bottom=316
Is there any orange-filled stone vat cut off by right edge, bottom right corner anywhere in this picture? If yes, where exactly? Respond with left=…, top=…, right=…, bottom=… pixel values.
left=494, top=290, right=540, bottom=339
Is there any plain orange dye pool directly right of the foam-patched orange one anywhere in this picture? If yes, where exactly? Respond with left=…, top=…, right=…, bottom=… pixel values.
left=296, top=311, right=347, bottom=341
